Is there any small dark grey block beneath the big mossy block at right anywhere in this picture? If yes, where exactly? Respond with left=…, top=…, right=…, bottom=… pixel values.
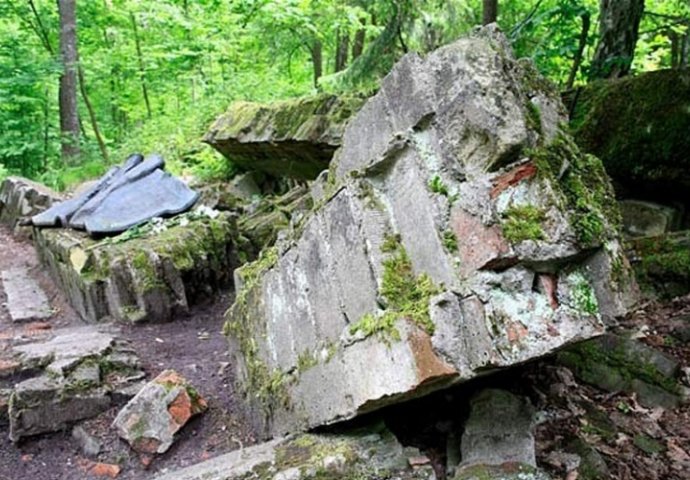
left=619, top=200, right=681, bottom=237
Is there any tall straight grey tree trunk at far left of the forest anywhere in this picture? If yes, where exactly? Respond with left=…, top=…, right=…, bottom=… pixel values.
left=58, top=0, right=79, bottom=164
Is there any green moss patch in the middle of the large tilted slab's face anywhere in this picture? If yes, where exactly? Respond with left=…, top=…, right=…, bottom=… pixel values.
left=350, top=237, right=440, bottom=341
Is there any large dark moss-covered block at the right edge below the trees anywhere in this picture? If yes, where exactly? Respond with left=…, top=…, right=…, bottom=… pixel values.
left=565, top=70, right=690, bottom=195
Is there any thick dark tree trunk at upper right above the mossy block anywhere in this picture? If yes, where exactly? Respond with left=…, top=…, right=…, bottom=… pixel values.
left=590, top=0, right=644, bottom=80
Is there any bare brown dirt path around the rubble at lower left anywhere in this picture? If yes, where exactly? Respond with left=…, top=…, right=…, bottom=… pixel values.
left=0, top=227, right=255, bottom=480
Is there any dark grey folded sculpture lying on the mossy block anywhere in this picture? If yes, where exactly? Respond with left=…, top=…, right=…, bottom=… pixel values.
left=31, top=154, right=199, bottom=235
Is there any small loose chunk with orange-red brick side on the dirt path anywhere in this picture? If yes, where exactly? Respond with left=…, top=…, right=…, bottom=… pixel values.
left=113, top=370, right=208, bottom=455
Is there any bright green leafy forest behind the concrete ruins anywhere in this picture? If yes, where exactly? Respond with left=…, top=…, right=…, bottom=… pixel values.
left=0, top=0, right=690, bottom=190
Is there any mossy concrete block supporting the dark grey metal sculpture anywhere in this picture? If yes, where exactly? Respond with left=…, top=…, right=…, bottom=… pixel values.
left=36, top=211, right=238, bottom=322
